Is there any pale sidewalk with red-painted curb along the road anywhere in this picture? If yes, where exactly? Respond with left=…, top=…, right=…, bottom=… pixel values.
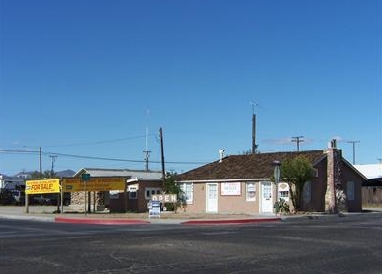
left=0, top=206, right=281, bottom=225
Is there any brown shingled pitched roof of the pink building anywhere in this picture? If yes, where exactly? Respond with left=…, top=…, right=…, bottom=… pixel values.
left=177, top=150, right=326, bottom=181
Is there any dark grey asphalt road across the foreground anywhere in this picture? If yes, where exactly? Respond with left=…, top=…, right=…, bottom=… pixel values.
left=0, top=213, right=382, bottom=274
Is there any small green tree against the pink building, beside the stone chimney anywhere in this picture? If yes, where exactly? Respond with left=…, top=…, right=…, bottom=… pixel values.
left=281, top=156, right=314, bottom=211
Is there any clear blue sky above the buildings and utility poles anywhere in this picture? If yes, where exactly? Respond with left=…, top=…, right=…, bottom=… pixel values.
left=0, top=0, right=382, bottom=175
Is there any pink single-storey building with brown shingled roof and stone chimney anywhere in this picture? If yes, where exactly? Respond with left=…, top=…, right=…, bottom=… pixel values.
left=177, top=148, right=364, bottom=214
